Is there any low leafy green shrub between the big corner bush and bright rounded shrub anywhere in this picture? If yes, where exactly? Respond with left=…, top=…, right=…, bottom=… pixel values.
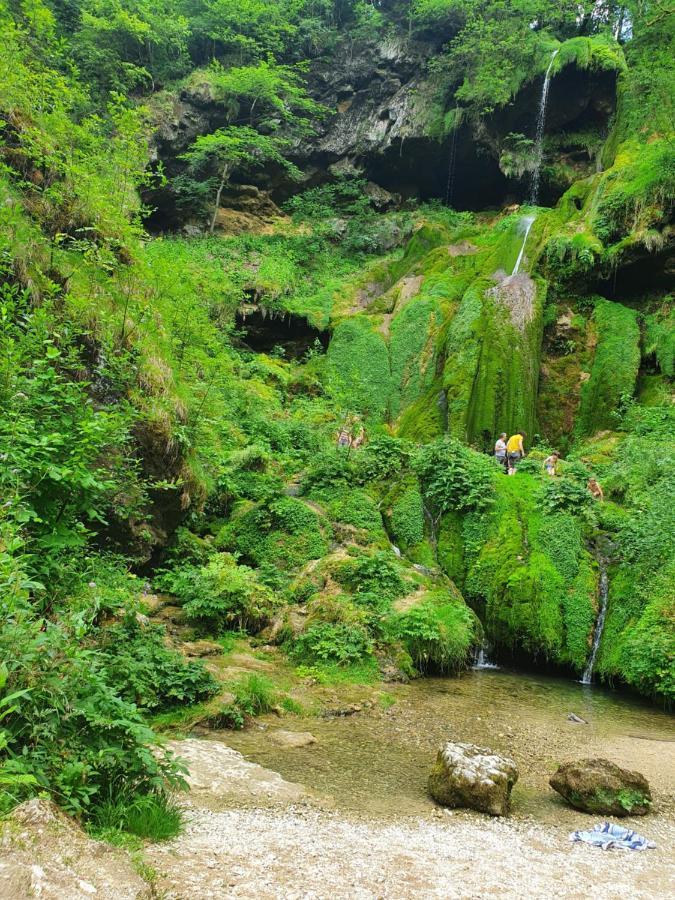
left=101, top=615, right=218, bottom=710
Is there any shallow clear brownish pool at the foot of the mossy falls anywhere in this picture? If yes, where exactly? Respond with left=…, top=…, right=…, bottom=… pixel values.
left=224, top=670, right=675, bottom=824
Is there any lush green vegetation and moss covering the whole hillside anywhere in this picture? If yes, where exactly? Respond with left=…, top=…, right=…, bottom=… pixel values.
left=0, top=0, right=675, bottom=841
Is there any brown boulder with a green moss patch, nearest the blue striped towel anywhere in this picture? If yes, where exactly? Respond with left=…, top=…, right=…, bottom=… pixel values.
left=549, top=759, right=652, bottom=816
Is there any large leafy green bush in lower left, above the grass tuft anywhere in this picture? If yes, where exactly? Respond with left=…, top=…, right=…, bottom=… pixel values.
left=0, top=616, right=183, bottom=815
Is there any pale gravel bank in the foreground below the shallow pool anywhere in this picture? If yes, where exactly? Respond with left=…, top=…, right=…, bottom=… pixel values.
left=147, top=741, right=675, bottom=900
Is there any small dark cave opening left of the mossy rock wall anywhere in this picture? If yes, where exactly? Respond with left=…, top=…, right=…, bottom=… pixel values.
left=236, top=306, right=330, bottom=359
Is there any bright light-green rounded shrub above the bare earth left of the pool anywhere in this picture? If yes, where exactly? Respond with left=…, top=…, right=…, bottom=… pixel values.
left=162, top=553, right=279, bottom=633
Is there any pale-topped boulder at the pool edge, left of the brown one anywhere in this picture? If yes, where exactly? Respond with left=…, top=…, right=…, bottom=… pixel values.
left=429, top=742, right=518, bottom=816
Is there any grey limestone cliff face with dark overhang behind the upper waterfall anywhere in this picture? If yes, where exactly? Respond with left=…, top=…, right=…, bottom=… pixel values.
left=151, top=38, right=616, bottom=227
